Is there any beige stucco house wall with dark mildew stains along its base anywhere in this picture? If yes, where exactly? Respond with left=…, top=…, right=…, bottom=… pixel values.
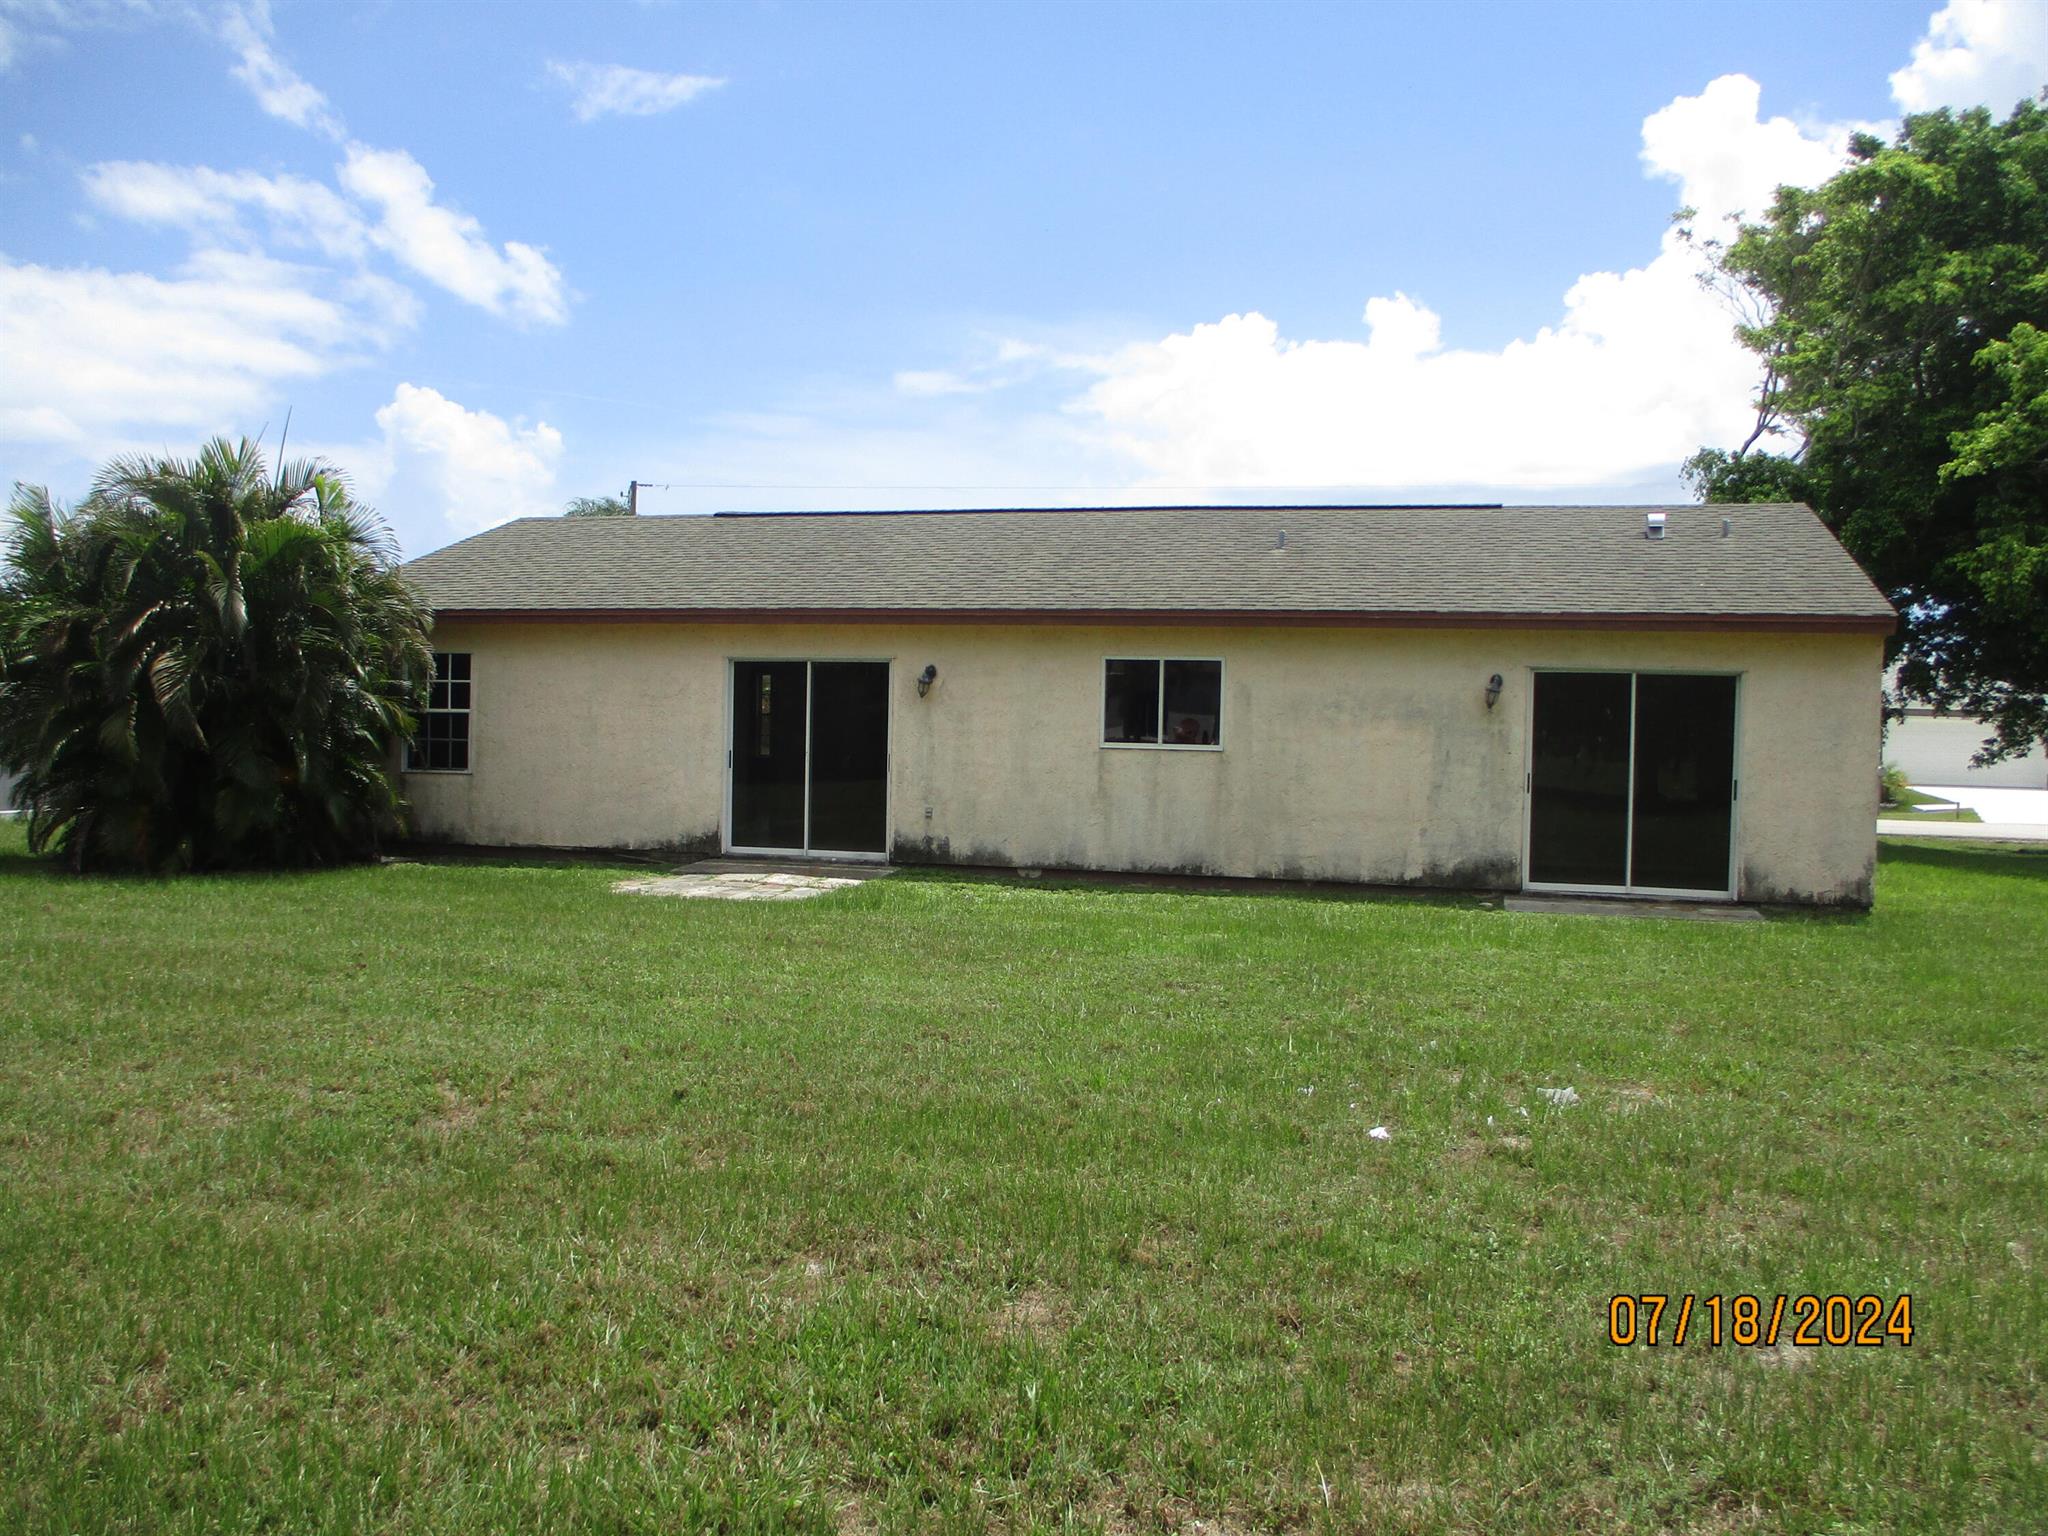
left=406, top=623, right=1880, bottom=903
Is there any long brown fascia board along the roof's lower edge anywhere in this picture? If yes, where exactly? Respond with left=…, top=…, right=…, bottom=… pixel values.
left=419, top=608, right=1898, bottom=635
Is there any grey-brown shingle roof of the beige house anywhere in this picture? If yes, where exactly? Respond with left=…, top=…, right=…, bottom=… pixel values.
left=406, top=504, right=1894, bottom=629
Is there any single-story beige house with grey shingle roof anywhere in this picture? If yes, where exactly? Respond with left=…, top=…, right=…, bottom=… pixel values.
left=406, top=506, right=1894, bottom=905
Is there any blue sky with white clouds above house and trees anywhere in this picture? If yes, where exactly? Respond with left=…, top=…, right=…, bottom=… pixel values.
left=0, top=0, right=2048, bottom=553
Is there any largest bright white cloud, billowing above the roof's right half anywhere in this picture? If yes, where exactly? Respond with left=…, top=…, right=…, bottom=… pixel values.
left=1069, top=76, right=1849, bottom=489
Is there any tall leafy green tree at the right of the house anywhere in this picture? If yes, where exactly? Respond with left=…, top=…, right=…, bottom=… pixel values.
left=1686, top=102, right=2048, bottom=758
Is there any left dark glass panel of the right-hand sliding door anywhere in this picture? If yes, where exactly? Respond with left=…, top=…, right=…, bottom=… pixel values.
left=1528, top=672, right=1632, bottom=885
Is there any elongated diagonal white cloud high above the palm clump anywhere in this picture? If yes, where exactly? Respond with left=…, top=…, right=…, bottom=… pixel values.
left=342, top=143, right=569, bottom=326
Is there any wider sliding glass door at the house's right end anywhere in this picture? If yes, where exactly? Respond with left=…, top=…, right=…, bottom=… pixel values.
left=1528, top=672, right=1735, bottom=895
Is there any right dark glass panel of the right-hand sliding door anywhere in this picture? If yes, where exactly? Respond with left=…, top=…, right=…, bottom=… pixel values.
left=1630, top=672, right=1735, bottom=893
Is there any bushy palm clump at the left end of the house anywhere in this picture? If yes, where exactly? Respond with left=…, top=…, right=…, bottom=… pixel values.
left=0, top=440, right=432, bottom=870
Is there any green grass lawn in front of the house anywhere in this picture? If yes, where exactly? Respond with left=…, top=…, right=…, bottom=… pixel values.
left=0, top=829, right=2048, bottom=1534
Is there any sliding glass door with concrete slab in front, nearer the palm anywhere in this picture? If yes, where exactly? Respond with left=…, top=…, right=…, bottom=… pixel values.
left=727, top=662, right=889, bottom=854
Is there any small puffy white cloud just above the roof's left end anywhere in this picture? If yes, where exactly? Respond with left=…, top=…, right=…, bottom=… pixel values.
left=371, top=383, right=561, bottom=535
